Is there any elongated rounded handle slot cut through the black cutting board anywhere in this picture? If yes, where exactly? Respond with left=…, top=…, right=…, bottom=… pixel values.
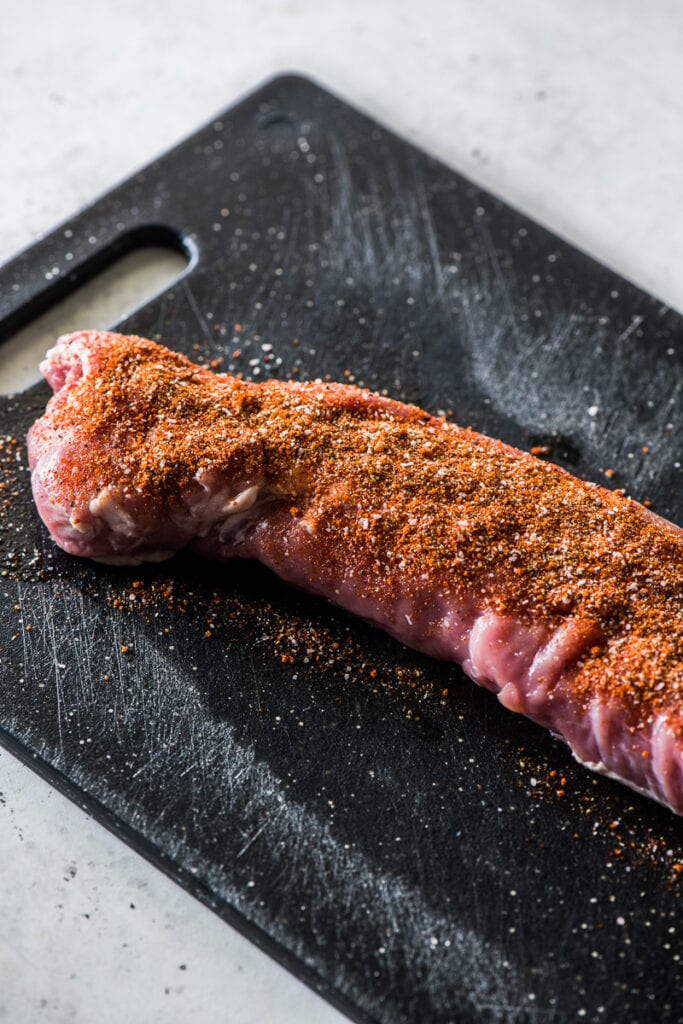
left=0, top=227, right=189, bottom=395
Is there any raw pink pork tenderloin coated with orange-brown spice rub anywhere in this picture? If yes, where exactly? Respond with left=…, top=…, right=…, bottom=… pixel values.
left=29, top=332, right=683, bottom=813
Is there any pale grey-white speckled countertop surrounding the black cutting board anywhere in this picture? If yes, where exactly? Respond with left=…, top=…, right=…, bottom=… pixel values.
left=0, top=0, right=683, bottom=1024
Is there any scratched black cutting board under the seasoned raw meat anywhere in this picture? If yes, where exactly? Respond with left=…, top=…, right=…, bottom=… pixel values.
left=0, top=77, right=683, bottom=1024
